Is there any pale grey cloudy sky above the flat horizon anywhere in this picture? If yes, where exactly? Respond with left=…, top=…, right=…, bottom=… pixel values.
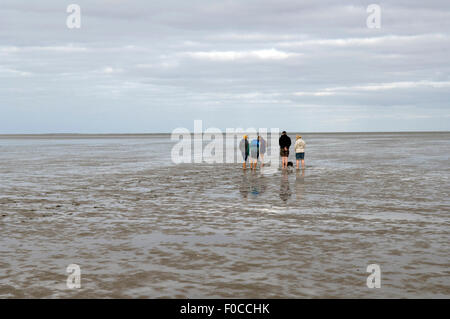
left=0, top=0, right=450, bottom=134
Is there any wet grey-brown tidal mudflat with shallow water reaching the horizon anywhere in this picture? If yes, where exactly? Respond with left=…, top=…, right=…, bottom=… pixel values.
left=0, top=133, right=450, bottom=298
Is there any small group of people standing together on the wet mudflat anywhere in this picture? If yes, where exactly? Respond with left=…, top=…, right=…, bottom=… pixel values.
left=239, top=131, right=306, bottom=169
